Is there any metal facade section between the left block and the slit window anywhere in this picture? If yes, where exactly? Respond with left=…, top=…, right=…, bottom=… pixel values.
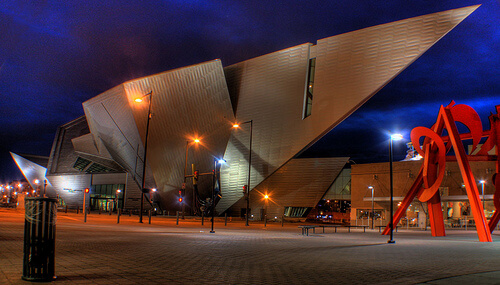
left=217, top=44, right=310, bottom=212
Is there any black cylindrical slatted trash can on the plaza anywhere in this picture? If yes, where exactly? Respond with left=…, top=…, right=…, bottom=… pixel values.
left=22, top=197, right=57, bottom=281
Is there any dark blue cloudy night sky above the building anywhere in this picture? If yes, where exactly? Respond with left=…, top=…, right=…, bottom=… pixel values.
left=0, top=0, right=500, bottom=183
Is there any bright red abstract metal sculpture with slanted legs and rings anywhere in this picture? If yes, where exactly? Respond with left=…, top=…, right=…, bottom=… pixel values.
left=382, top=101, right=500, bottom=242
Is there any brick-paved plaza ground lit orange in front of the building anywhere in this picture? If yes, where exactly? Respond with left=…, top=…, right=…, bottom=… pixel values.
left=0, top=209, right=500, bottom=284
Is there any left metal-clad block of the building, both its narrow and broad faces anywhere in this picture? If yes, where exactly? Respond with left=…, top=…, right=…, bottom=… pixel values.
left=83, top=60, right=234, bottom=207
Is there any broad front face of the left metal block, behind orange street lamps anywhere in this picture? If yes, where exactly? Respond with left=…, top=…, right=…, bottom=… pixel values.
left=124, top=60, right=234, bottom=208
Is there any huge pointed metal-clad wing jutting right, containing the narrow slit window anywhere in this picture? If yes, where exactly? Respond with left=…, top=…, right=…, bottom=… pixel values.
left=217, top=6, right=478, bottom=212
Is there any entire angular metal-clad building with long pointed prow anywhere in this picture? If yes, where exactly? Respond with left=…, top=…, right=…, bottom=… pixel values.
left=13, top=6, right=478, bottom=216
